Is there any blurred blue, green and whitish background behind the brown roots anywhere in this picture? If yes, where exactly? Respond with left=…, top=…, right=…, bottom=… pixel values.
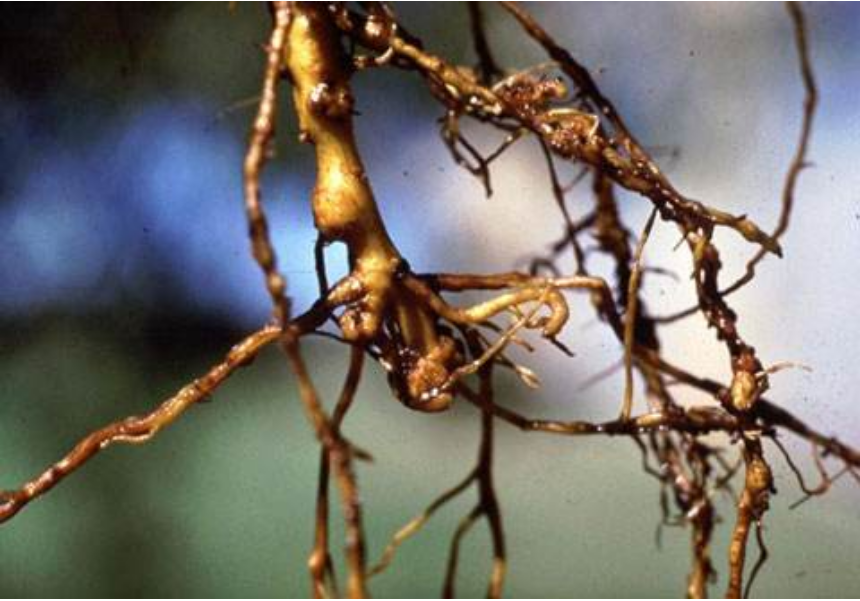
left=0, top=3, right=860, bottom=597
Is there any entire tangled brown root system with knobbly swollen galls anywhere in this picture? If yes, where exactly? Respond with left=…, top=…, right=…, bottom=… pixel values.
left=0, top=2, right=860, bottom=598
